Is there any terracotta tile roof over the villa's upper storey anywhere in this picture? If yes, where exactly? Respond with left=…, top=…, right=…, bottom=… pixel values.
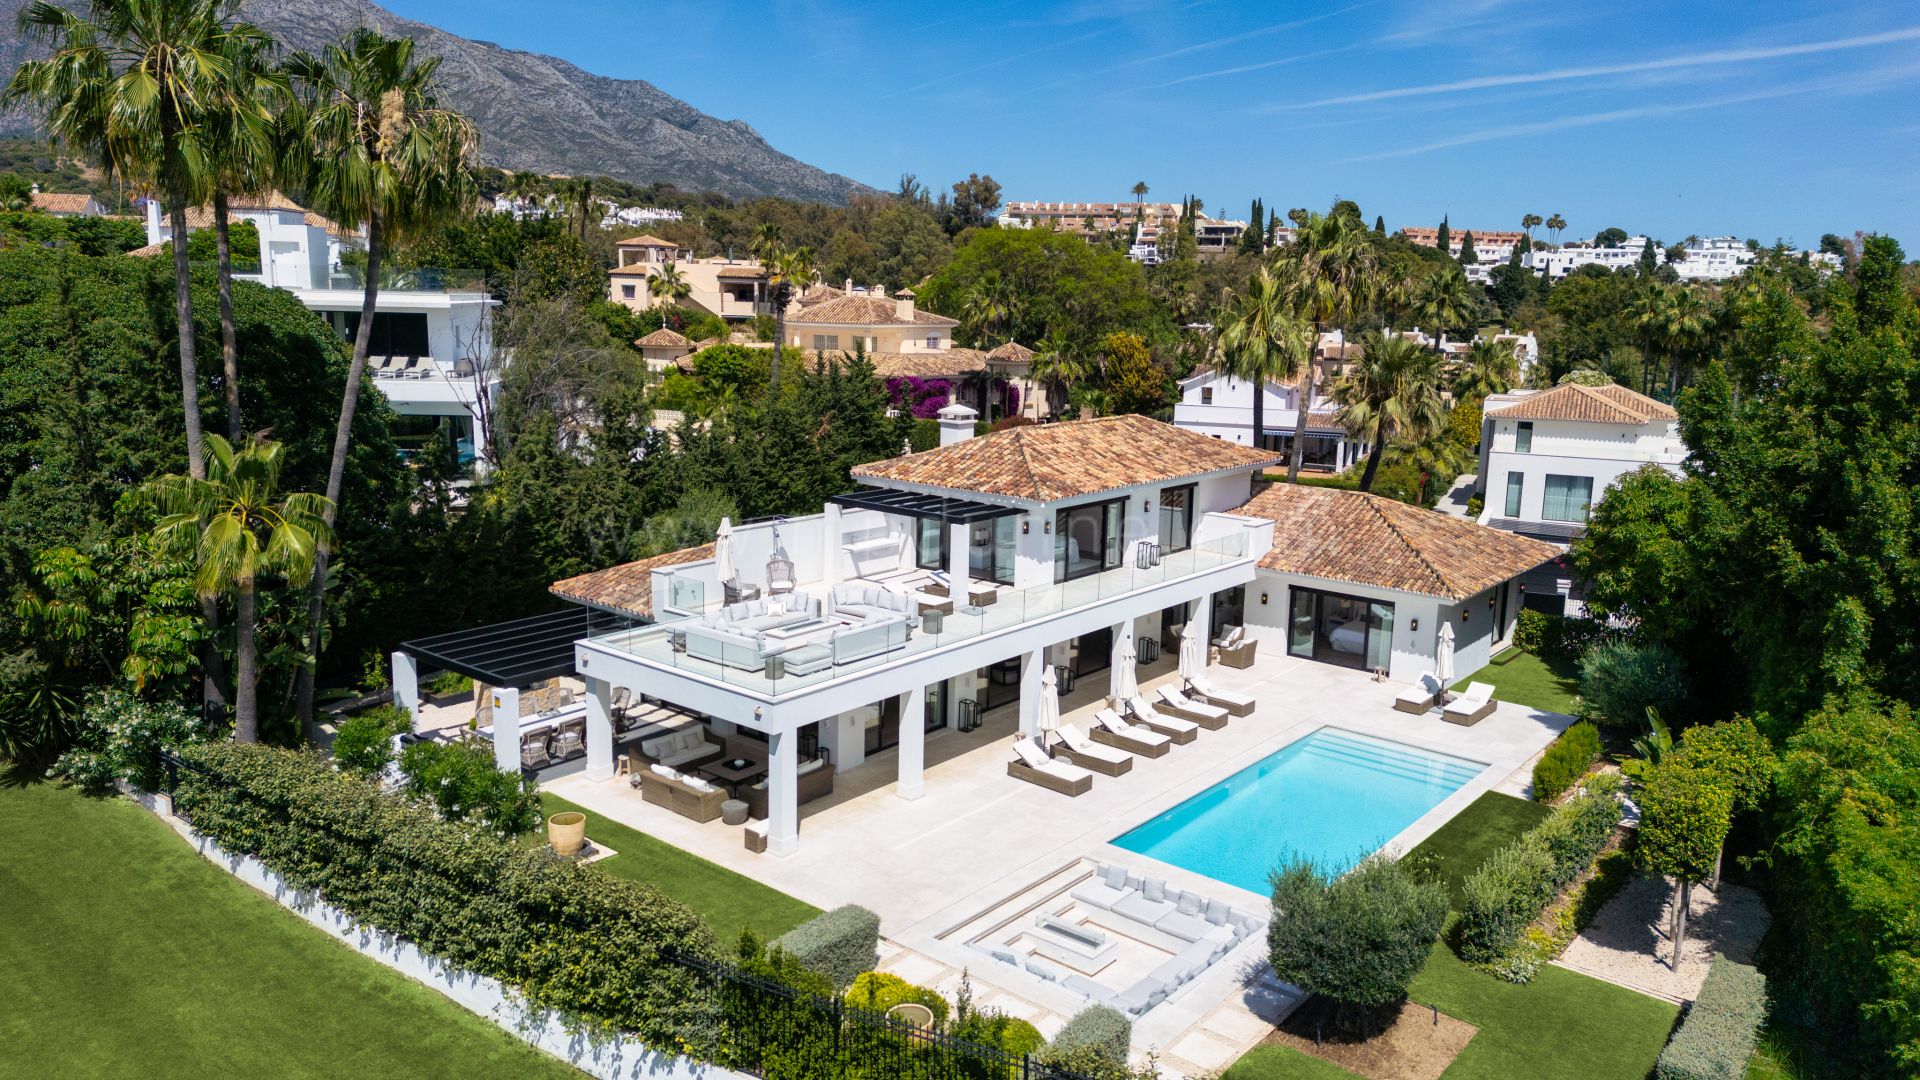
left=852, top=415, right=1281, bottom=502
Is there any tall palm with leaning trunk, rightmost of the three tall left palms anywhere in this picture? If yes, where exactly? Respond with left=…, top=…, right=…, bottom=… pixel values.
left=286, top=27, right=478, bottom=724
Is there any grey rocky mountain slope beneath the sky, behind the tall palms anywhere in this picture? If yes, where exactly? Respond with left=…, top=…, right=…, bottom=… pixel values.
left=0, top=0, right=870, bottom=202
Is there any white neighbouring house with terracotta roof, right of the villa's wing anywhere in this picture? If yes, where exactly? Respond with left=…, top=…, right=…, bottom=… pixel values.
left=1478, top=382, right=1686, bottom=544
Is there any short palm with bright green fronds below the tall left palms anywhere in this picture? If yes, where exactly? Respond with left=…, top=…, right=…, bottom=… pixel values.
left=144, top=434, right=332, bottom=742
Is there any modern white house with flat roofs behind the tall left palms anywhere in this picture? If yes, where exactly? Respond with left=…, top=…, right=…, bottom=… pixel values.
left=146, top=192, right=499, bottom=461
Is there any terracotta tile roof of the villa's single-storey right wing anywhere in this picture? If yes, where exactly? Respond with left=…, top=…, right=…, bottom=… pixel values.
left=1235, top=484, right=1561, bottom=600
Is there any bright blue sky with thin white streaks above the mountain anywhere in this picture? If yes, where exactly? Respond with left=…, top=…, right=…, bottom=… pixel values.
left=388, top=0, right=1920, bottom=252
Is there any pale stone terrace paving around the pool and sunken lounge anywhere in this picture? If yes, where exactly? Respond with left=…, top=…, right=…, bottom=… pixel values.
left=543, top=628, right=1572, bottom=1074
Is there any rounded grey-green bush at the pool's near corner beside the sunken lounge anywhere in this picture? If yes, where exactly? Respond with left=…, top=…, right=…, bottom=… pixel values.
left=1267, top=855, right=1448, bottom=1032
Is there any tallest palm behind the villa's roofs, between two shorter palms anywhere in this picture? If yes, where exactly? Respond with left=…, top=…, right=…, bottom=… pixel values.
left=1275, top=211, right=1382, bottom=482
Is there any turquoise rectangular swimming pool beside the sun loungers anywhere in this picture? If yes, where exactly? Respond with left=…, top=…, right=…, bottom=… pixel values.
left=1114, top=728, right=1486, bottom=894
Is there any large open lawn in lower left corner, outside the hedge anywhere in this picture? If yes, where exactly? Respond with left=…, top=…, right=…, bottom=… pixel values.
left=0, top=784, right=580, bottom=1080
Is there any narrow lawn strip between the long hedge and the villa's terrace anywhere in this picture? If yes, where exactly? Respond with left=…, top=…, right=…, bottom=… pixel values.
left=540, top=794, right=820, bottom=945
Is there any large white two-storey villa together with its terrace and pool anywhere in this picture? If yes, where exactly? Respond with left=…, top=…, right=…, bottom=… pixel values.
left=394, top=409, right=1567, bottom=1070
